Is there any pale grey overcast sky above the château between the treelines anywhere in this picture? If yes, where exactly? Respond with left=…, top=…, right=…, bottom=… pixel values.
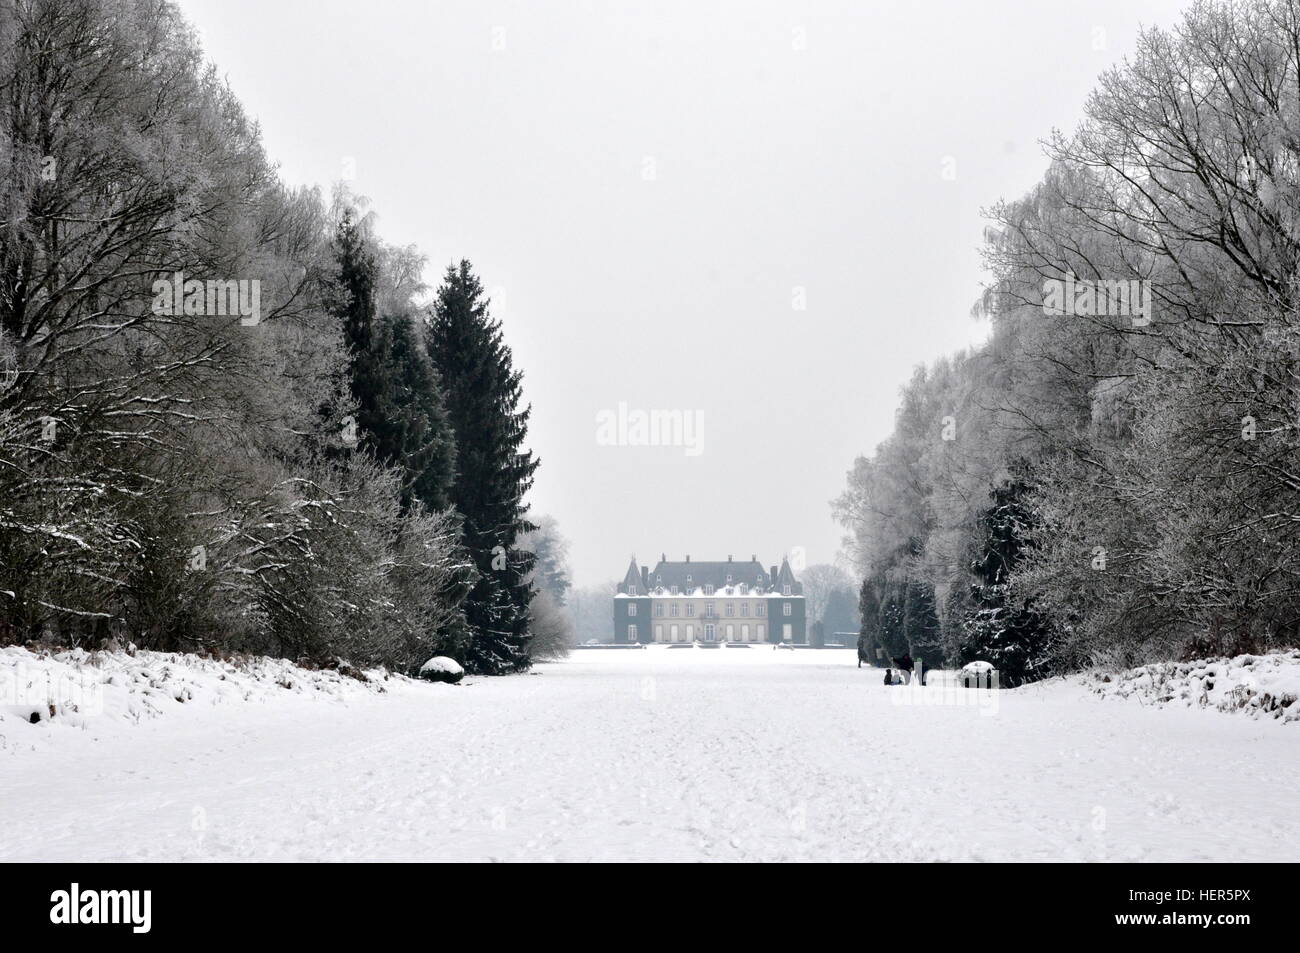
left=181, top=0, right=1187, bottom=582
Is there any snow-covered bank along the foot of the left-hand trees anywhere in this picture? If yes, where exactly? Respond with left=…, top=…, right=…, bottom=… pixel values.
left=0, top=646, right=413, bottom=748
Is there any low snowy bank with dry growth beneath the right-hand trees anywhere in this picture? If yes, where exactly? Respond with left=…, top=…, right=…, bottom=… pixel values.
left=1086, top=651, right=1300, bottom=722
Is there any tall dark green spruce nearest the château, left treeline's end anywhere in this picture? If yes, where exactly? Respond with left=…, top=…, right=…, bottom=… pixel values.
left=426, top=261, right=538, bottom=675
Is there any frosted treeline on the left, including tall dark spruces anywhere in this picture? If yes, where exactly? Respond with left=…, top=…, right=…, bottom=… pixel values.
left=0, top=0, right=537, bottom=673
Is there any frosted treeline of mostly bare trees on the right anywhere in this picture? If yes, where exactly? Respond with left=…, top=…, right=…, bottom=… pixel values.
left=836, top=1, right=1300, bottom=683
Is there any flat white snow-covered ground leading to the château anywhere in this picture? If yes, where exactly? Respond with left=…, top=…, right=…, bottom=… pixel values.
left=0, top=646, right=1300, bottom=861
